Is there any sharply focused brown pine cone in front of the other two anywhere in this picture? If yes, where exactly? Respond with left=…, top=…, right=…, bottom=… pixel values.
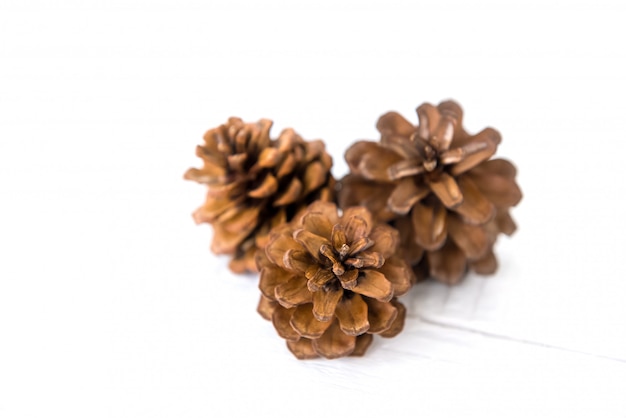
left=257, top=202, right=412, bottom=359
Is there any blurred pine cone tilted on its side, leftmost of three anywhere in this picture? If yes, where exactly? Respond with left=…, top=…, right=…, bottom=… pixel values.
left=185, top=118, right=335, bottom=273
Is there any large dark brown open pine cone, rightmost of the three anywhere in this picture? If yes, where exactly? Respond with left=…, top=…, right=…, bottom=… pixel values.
left=339, top=101, right=522, bottom=284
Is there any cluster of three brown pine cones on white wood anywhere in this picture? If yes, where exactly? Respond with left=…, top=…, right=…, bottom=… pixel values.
left=185, top=101, right=522, bottom=359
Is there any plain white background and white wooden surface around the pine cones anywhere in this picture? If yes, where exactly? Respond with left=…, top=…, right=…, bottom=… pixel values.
left=0, top=0, right=626, bottom=418
